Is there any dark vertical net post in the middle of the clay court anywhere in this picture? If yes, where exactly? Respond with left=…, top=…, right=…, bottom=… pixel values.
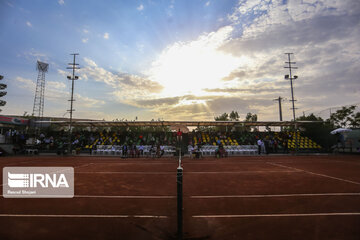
left=176, top=158, right=183, bottom=240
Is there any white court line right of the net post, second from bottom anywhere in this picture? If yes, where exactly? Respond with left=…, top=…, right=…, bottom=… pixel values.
left=190, top=193, right=360, bottom=198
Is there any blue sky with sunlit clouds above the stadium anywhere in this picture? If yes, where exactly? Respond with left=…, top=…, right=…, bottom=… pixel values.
left=0, top=0, right=360, bottom=121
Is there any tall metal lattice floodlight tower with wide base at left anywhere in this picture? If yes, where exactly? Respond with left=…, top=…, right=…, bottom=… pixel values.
left=33, top=61, right=49, bottom=118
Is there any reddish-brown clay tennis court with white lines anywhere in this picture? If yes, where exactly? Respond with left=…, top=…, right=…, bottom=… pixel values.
left=0, top=155, right=360, bottom=239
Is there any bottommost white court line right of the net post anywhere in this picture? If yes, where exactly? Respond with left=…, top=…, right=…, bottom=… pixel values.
left=192, top=212, right=360, bottom=218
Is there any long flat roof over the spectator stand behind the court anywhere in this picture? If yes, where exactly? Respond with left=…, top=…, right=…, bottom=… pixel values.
left=35, top=120, right=319, bottom=127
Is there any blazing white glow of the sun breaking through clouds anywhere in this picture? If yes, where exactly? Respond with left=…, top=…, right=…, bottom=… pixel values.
left=150, top=28, right=242, bottom=97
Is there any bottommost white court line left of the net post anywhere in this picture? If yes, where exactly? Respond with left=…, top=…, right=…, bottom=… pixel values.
left=0, top=214, right=168, bottom=218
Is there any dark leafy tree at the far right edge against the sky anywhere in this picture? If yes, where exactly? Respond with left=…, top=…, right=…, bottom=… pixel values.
left=329, top=105, right=360, bottom=128
